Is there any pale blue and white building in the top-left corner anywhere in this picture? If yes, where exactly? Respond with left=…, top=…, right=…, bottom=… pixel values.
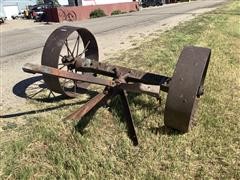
left=0, top=0, right=36, bottom=19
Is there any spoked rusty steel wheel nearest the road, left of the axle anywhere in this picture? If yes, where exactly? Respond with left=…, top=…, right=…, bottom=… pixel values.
left=41, top=26, right=99, bottom=97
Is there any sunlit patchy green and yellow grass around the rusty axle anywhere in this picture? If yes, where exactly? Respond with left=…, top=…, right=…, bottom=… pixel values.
left=0, top=1, right=240, bottom=179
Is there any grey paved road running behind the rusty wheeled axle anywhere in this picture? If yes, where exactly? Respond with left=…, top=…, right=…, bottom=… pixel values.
left=0, top=0, right=227, bottom=57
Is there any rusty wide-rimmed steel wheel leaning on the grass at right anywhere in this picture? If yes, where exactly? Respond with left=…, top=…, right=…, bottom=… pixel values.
left=164, top=46, right=211, bottom=132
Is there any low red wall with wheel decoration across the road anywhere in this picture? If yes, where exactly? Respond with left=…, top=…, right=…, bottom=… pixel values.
left=46, top=0, right=139, bottom=22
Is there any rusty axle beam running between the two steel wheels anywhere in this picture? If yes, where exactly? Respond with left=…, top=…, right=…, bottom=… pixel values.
left=75, top=58, right=171, bottom=92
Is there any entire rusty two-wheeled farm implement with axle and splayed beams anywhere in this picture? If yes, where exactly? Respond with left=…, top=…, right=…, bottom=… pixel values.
left=23, top=26, right=211, bottom=145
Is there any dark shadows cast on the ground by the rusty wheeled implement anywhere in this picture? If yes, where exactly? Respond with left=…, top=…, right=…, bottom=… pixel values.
left=10, top=76, right=181, bottom=135
